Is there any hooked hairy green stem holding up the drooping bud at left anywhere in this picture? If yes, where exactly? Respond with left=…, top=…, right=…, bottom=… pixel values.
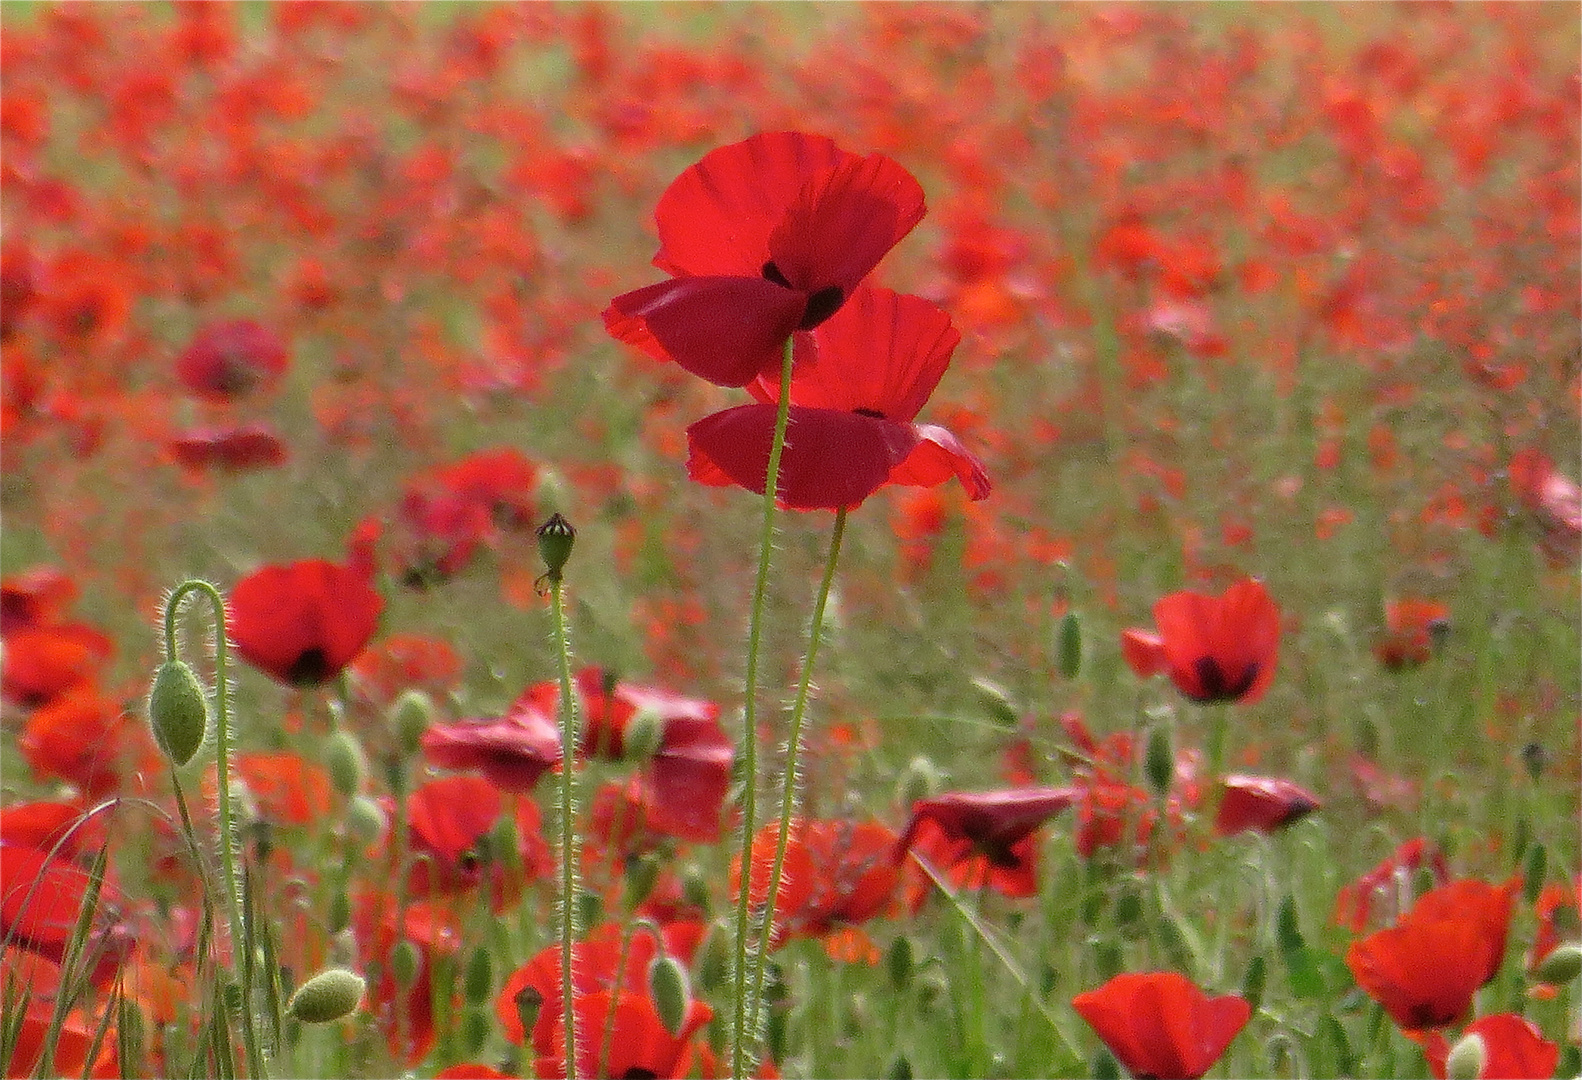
left=165, top=579, right=269, bottom=1077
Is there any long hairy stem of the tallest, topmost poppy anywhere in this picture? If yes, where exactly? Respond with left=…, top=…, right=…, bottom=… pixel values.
left=731, top=337, right=796, bottom=1080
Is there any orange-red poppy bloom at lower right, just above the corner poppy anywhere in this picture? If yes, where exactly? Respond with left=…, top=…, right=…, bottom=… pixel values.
left=1346, top=879, right=1520, bottom=1031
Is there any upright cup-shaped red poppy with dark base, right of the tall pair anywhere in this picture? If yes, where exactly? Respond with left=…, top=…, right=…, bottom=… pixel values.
left=1153, top=579, right=1280, bottom=704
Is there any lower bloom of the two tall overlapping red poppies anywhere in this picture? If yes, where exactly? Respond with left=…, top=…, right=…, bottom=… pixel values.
left=687, top=288, right=989, bottom=509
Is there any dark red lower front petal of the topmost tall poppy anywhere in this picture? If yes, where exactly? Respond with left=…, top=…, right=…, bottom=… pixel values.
left=604, top=277, right=807, bottom=386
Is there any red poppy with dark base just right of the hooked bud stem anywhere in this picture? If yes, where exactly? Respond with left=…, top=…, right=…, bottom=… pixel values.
left=229, top=558, right=384, bottom=686
